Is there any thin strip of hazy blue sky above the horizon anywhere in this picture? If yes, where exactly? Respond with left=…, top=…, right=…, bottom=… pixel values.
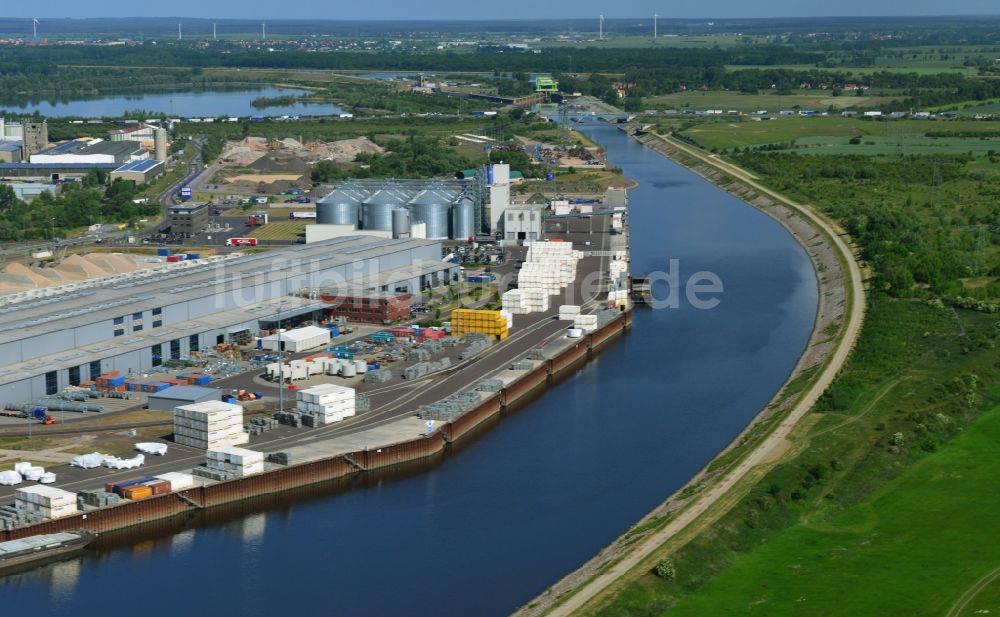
left=11, top=0, right=1000, bottom=20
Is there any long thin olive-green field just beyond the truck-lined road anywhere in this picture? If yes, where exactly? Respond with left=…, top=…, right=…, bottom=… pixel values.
left=644, top=90, right=896, bottom=113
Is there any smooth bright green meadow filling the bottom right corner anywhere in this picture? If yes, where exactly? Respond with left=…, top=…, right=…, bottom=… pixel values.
left=626, top=406, right=1000, bottom=617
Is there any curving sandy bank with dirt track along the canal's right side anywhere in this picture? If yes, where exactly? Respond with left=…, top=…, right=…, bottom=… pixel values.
left=516, top=127, right=865, bottom=616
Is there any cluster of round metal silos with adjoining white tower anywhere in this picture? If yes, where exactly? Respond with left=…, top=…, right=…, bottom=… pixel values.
left=314, top=164, right=510, bottom=242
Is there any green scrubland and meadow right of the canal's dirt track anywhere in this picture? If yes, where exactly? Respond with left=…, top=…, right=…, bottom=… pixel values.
left=594, top=123, right=1000, bottom=615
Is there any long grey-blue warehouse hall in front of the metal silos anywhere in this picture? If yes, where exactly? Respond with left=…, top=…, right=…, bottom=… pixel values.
left=0, top=236, right=458, bottom=405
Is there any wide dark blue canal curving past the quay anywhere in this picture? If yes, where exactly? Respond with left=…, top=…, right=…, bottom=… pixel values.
left=0, top=124, right=817, bottom=617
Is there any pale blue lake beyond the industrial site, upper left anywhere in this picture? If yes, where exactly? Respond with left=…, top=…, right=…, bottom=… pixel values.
left=0, top=86, right=342, bottom=118
